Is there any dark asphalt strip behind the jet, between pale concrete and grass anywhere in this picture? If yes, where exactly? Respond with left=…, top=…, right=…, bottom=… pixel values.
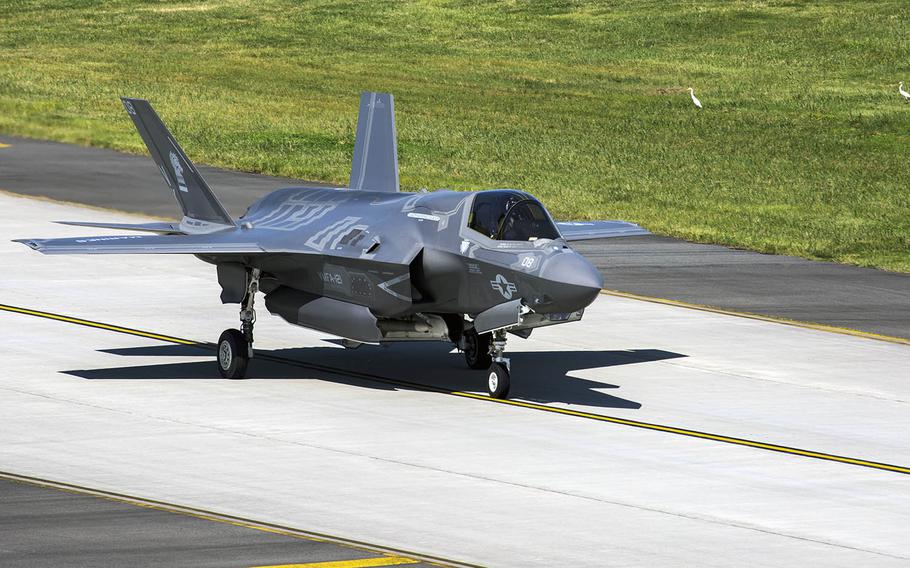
left=0, top=135, right=910, bottom=339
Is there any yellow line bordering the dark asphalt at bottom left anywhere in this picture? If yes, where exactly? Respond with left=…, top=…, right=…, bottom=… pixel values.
left=0, top=471, right=476, bottom=568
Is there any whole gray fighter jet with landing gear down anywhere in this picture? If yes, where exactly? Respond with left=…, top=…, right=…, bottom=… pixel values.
left=17, top=93, right=647, bottom=398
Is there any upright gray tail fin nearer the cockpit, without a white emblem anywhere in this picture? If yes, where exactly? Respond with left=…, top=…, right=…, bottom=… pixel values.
left=350, top=93, right=398, bottom=192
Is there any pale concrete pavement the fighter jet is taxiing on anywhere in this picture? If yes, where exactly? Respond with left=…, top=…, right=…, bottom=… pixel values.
left=0, top=195, right=910, bottom=567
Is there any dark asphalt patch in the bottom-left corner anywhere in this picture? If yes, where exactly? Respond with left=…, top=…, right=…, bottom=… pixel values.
left=0, top=473, right=439, bottom=568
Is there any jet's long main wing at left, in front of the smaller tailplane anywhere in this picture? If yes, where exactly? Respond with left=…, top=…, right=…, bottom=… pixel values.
left=15, top=233, right=271, bottom=254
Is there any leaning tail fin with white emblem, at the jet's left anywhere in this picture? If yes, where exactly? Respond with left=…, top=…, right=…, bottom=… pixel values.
left=120, top=98, right=235, bottom=230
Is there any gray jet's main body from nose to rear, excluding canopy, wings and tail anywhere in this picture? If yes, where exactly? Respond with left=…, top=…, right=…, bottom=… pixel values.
left=202, top=187, right=602, bottom=342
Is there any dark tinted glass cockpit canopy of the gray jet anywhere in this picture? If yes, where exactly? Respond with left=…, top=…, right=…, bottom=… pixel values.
left=468, top=189, right=560, bottom=241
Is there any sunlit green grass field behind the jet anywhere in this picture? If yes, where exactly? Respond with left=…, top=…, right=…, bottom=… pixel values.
left=0, top=0, right=910, bottom=272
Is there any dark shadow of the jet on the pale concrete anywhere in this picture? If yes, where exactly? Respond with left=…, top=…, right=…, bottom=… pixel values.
left=63, top=343, right=685, bottom=409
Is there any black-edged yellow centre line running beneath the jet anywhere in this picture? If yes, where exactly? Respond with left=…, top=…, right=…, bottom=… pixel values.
left=0, top=304, right=910, bottom=475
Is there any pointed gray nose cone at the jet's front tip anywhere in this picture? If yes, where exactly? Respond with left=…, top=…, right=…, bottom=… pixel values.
left=541, top=251, right=604, bottom=312
